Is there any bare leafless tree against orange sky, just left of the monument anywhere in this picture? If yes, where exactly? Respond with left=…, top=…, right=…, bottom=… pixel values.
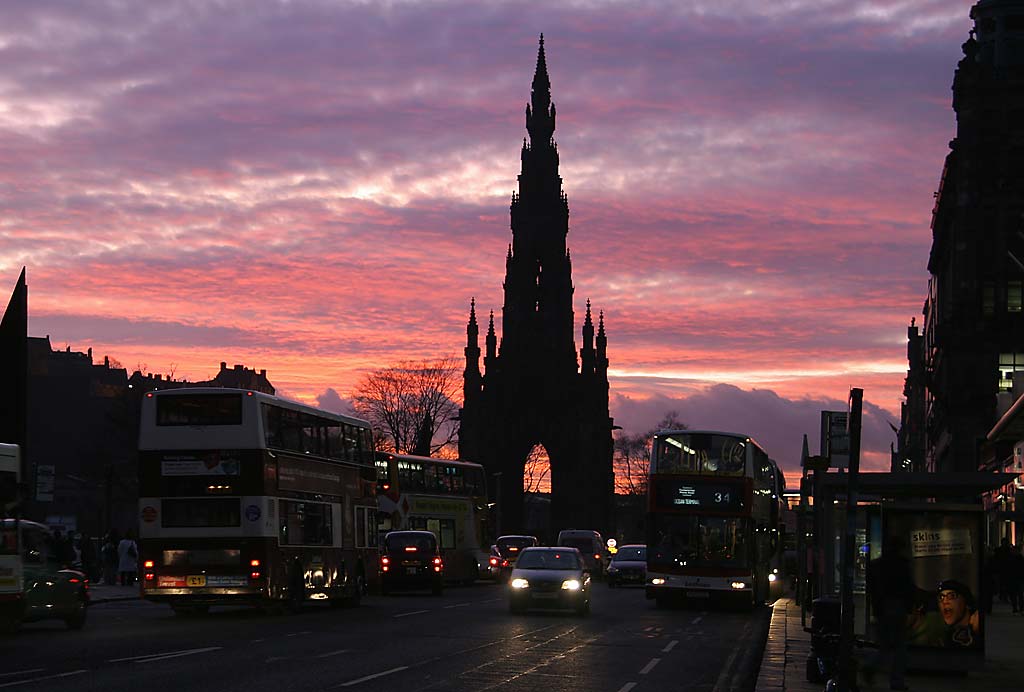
left=351, top=356, right=461, bottom=457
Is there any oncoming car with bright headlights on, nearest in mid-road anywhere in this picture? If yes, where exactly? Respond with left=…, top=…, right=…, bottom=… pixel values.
left=508, top=547, right=590, bottom=615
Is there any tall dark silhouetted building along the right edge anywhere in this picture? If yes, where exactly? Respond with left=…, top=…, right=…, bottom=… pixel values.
left=904, top=0, right=1024, bottom=471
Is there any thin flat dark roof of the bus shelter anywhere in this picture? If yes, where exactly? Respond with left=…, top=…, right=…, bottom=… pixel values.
left=809, top=471, right=1017, bottom=500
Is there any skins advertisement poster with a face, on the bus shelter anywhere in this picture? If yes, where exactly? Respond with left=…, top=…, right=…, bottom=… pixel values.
left=882, top=505, right=984, bottom=652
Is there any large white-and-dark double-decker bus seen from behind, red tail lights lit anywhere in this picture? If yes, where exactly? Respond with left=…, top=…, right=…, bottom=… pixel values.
left=139, top=388, right=377, bottom=613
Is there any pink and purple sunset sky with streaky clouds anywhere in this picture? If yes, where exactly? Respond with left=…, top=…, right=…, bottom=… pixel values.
left=0, top=0, right=972, bottom=481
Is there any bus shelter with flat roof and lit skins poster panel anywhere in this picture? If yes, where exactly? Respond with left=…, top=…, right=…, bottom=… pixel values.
left=800, top=471, right=1012, bottom=671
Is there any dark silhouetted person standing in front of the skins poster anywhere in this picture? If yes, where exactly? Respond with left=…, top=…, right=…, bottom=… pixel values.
left=864, top=536, right=918, bottom=690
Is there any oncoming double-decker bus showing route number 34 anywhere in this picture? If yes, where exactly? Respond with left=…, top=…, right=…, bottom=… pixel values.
left=646, top=430, right=784, bottom=606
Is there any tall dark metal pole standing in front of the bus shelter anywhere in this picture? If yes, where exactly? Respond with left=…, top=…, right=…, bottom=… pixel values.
left=838, top=388, right=864, bottom=692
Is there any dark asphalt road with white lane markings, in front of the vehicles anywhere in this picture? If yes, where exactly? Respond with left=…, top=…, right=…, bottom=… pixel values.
left=0, top=583, right=767, bottom=692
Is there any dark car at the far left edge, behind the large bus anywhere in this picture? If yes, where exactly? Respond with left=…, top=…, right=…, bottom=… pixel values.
left=0, top=519, right=89, bottom=633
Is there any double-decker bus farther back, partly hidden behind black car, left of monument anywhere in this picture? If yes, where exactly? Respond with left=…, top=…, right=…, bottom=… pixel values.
left=377, top=452, right=487, bottom=583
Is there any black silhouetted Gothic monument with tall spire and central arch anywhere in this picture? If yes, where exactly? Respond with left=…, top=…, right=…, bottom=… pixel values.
left=459, top=35, right=614, bottom=532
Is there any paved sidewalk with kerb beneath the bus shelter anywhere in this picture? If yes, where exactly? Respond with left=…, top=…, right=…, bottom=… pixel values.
left=754, top=598, right=1024, bottom=692
